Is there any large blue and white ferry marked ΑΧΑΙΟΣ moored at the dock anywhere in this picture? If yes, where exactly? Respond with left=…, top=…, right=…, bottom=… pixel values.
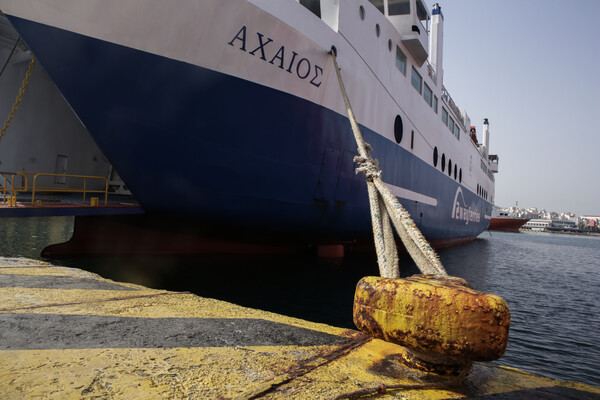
left=0, top=0, right=498, bottom=247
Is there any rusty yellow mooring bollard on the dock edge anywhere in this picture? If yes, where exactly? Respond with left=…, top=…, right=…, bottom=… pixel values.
left=354, top=275, right=510, bottom=377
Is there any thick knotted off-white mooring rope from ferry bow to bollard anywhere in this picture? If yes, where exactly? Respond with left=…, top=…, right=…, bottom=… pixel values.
left=330, top=49, right=447, bottom=278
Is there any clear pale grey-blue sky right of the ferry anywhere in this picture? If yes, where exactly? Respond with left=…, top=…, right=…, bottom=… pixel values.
left=436, top=0, right=600, bottom=215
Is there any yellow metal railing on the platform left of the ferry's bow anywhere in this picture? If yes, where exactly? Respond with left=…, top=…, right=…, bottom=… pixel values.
left=0, top=172, right=108, bottom=205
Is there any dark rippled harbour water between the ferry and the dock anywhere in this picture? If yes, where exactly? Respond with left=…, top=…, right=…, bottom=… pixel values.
left=0, top=218, right=600, bottom=386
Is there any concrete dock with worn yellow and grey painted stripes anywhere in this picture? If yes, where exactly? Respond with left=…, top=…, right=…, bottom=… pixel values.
left=0, top=257, right=600, bottom=399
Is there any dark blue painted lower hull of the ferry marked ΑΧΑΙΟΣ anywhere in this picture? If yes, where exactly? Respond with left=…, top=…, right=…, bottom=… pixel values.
left=10, top=17, right=492, bottom=243
